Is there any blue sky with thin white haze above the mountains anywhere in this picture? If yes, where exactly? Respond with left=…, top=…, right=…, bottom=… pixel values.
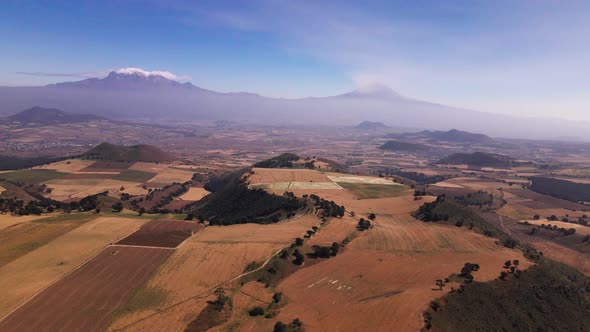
left=0, top=0, right=590, bottom=121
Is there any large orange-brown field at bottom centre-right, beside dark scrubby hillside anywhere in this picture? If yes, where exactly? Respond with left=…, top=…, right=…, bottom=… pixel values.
left=276, top=246, right=530, bottom=331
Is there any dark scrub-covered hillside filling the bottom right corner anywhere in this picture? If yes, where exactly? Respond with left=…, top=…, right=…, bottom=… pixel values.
left=430, top=259, right=590, bottom=331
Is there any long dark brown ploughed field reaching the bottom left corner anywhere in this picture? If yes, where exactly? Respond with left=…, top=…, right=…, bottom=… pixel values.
left=0, top=247, right=172, bottom=331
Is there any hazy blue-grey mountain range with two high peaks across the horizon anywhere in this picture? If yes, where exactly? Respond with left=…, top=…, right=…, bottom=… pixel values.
left=0, top=71, right=590, bottom=138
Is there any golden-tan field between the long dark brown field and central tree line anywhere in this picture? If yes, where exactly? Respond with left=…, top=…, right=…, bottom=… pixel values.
left=110, top=215, right=319, bottom=331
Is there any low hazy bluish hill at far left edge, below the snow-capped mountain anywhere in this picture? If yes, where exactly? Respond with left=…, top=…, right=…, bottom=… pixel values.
left=0, top=106, right=105, bottom=126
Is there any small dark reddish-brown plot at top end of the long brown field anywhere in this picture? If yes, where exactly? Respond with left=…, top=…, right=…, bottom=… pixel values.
left=116, top=220, right=203, bottom=248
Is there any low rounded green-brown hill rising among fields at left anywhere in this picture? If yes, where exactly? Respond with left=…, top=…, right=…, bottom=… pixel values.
left=81, top=142, right=176, bottom=162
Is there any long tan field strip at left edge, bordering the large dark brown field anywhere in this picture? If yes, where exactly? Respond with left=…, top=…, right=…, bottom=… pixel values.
left=0, top=218, right=145, bottom=317
